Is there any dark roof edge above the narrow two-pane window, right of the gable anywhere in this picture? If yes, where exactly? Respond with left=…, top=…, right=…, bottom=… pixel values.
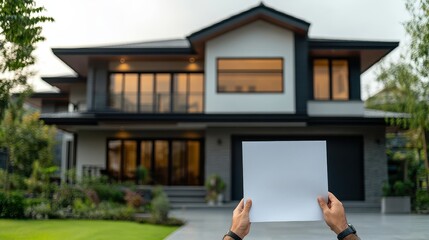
left=309, top=39, right=399, bottom=50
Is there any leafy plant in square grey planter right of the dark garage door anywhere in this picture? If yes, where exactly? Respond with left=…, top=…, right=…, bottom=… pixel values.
left=381, top=180, right=413, bottom=213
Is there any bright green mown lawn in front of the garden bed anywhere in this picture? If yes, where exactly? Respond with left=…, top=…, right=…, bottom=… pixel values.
left=0, top=219, right=177, bottom=240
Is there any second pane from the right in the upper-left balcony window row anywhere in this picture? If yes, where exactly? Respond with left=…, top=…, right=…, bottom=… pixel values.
left=173, top=74, right=188, bottom=113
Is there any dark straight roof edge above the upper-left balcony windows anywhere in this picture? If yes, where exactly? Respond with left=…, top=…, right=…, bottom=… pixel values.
left=52, top=47, right=195, bottom=56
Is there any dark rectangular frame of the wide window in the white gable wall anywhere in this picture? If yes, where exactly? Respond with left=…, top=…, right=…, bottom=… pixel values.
left=216, top=57, right=285, bottom=94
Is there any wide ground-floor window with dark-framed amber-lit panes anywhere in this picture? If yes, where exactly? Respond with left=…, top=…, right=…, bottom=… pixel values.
left=107, top=139, right=203, bottom=186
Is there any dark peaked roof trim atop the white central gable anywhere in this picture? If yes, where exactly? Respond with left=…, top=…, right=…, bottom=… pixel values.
left=188, top=3, right=310, bottom=42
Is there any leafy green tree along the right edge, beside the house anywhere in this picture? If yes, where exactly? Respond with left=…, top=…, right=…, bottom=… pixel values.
left=368, top=0, right=429, bottom=186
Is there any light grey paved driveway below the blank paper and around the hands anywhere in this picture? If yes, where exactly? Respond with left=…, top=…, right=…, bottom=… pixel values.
left=167, top=208, right=429, bottom=240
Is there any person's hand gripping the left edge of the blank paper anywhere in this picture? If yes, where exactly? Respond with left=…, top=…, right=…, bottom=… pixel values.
left=223, top=199, right=252, bottom=240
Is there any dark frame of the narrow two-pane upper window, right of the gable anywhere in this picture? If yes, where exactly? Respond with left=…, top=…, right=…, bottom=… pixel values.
left=311, top=57, right=351, bottom=102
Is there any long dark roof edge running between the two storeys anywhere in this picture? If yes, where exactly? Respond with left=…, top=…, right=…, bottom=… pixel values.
left=41, top=113, right=385, bottom=125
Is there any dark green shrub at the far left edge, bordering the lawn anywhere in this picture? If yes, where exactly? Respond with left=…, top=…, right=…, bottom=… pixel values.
left=0, top=192, right=25, bottom=218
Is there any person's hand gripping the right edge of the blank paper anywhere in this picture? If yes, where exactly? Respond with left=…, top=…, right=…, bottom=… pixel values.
left=317, top=193, right=360, bottom=240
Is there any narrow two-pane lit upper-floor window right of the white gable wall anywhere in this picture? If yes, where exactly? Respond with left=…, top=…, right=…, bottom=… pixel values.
left=313, top=59, right=349, bottom=100
